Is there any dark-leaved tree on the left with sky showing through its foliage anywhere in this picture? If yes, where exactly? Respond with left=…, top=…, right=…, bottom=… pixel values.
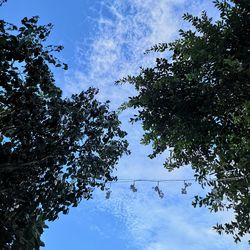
left=0, top=17, right=128, bottom=249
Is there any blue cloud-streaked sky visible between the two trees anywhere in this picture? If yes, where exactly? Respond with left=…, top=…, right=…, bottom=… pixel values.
left=0, top=0, right=248, bottom=250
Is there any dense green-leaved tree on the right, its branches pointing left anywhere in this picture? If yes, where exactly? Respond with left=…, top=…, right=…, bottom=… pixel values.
left=118, top=0, right=250, bottom=242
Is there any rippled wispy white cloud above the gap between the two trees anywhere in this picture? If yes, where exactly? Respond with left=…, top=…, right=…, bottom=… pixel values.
left=66, top=0, right=191, bottom=105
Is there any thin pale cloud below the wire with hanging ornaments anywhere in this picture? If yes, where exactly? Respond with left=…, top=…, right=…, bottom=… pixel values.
left=91, top=184, right=246, bottom=250
